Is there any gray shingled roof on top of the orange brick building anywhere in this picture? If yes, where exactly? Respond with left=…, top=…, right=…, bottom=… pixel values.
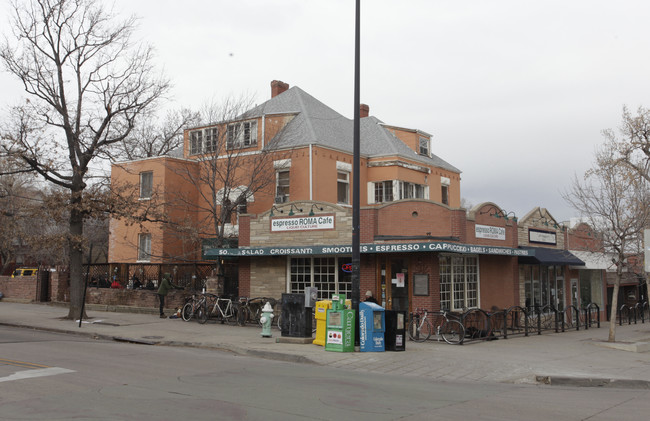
left=242, top=86, right=460, bottom=173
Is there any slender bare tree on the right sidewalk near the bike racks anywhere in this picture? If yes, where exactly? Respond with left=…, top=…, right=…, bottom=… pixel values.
left=564, top=147, right=650, bottom=342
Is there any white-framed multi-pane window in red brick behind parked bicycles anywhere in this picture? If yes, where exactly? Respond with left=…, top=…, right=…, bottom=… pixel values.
left=440, top=255, right=479, bottom=311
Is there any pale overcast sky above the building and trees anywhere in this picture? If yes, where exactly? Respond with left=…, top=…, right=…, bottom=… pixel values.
left=0, top=0, right=650, bottom=221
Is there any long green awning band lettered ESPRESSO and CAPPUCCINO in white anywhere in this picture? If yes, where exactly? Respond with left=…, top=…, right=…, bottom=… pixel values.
left=203, top=242, right=535, bottom=259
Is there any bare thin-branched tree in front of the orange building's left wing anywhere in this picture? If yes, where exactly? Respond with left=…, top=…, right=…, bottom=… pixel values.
left=168, top=98, right=289, bottom=274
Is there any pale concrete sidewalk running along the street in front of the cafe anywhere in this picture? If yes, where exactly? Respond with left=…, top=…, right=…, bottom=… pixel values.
left=0, top=301, right=650, bottom=389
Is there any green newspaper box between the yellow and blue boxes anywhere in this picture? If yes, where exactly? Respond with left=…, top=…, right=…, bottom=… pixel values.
left=325, top=295, right=356, bottom=352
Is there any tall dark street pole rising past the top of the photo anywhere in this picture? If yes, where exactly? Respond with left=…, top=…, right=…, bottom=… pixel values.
left=352, top=0, right=361, bottom=345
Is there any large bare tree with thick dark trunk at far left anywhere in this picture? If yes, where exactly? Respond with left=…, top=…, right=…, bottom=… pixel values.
left=0, top=0, right=169, bottom=318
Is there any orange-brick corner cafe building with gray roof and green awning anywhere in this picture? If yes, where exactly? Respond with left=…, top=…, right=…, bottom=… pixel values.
left=109, top=81, right=600, bottom=311
